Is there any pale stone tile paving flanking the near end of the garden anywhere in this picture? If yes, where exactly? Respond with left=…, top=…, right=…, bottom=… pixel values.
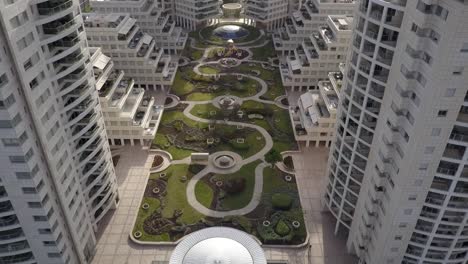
left=92, top=146, right=357, bottom=264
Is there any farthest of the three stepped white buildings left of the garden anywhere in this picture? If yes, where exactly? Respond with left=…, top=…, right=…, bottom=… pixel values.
left=90, top=0, right=188, bottom=54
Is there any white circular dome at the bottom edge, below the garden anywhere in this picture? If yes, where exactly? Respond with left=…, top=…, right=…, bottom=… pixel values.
left=169, top=227, right=267, bottom=264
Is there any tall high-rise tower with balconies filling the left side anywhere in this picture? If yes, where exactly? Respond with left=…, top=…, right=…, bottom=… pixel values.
left=0, top=0, right=119, bottom=263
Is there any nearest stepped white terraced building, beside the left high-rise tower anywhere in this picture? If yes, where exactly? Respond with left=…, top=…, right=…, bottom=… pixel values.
left=91, top=48, right=164, bottom=146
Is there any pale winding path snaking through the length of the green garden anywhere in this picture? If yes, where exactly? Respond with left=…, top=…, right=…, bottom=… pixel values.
left=172, top=35, right=286, bottom=218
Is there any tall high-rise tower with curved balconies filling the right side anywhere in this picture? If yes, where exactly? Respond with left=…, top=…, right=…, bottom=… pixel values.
left=325, top=0, right=468, bottom=264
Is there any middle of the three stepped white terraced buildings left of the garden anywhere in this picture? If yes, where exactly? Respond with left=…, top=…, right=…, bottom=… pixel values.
left=83, top=13, right=178, bottom=90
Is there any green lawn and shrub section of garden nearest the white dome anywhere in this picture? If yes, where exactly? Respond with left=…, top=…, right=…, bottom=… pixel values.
left=133, top=162, right=307, bottom=245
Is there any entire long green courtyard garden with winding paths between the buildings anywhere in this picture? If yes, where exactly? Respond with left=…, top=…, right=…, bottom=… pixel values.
left=132, top=24, right=307, bottom=245
